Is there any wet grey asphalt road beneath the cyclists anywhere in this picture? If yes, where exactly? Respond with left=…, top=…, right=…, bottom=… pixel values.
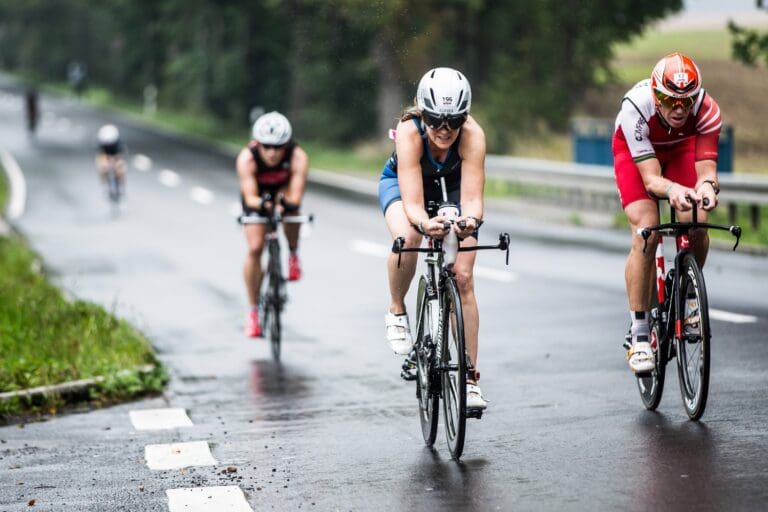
left=0, top=82, right=768, bottom=511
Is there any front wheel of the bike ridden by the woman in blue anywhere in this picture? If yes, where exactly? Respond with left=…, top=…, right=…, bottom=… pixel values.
left=440, top=278, right=467, bottom=460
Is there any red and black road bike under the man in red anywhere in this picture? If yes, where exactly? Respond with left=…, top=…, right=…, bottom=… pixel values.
left=625, top=200, right=741, bottom=420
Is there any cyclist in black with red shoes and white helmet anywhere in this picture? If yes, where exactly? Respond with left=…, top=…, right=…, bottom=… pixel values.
left=236, top=112, right=309, bottom=337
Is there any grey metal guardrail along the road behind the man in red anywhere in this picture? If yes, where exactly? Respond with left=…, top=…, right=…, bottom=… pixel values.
left=485, top=155, right=768, bottom=227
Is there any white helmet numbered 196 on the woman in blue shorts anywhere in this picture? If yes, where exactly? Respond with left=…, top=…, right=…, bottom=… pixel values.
left=416, top=68, right=472, bottom=116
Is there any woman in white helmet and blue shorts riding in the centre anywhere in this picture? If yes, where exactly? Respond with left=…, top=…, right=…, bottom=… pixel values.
left=379, top=68, right=486, bottom=409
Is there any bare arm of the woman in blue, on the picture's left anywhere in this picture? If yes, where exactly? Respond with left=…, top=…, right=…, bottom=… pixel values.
left=395, top=120, right=446, bottom=238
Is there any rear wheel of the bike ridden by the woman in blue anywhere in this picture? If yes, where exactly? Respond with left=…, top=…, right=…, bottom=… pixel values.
left=415, top=276, right=440, bottom=446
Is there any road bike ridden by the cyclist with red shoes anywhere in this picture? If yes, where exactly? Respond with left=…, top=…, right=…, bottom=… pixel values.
left=238, top=194, right=314, bottom=361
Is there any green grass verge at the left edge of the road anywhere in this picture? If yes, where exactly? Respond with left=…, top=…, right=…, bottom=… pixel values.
left=0, top=164, right=168, bottom=422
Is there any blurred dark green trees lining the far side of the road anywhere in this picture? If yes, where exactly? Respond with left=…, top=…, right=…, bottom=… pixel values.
left=0, top=0, right=682, bottom=151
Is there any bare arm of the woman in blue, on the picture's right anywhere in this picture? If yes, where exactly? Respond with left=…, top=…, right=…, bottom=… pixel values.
left=457, top=116, right=485, bottom=238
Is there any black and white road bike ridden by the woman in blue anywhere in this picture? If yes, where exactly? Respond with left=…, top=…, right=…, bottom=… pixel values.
left=392, top=203, right=509, bottom=460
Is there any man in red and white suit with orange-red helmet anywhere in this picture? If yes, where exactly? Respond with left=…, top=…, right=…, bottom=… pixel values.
left=612, top=53, right=722, bottom=373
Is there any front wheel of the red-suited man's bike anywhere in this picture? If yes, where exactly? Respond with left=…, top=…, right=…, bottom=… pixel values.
left=677, top=253, right=711, bottom=420
